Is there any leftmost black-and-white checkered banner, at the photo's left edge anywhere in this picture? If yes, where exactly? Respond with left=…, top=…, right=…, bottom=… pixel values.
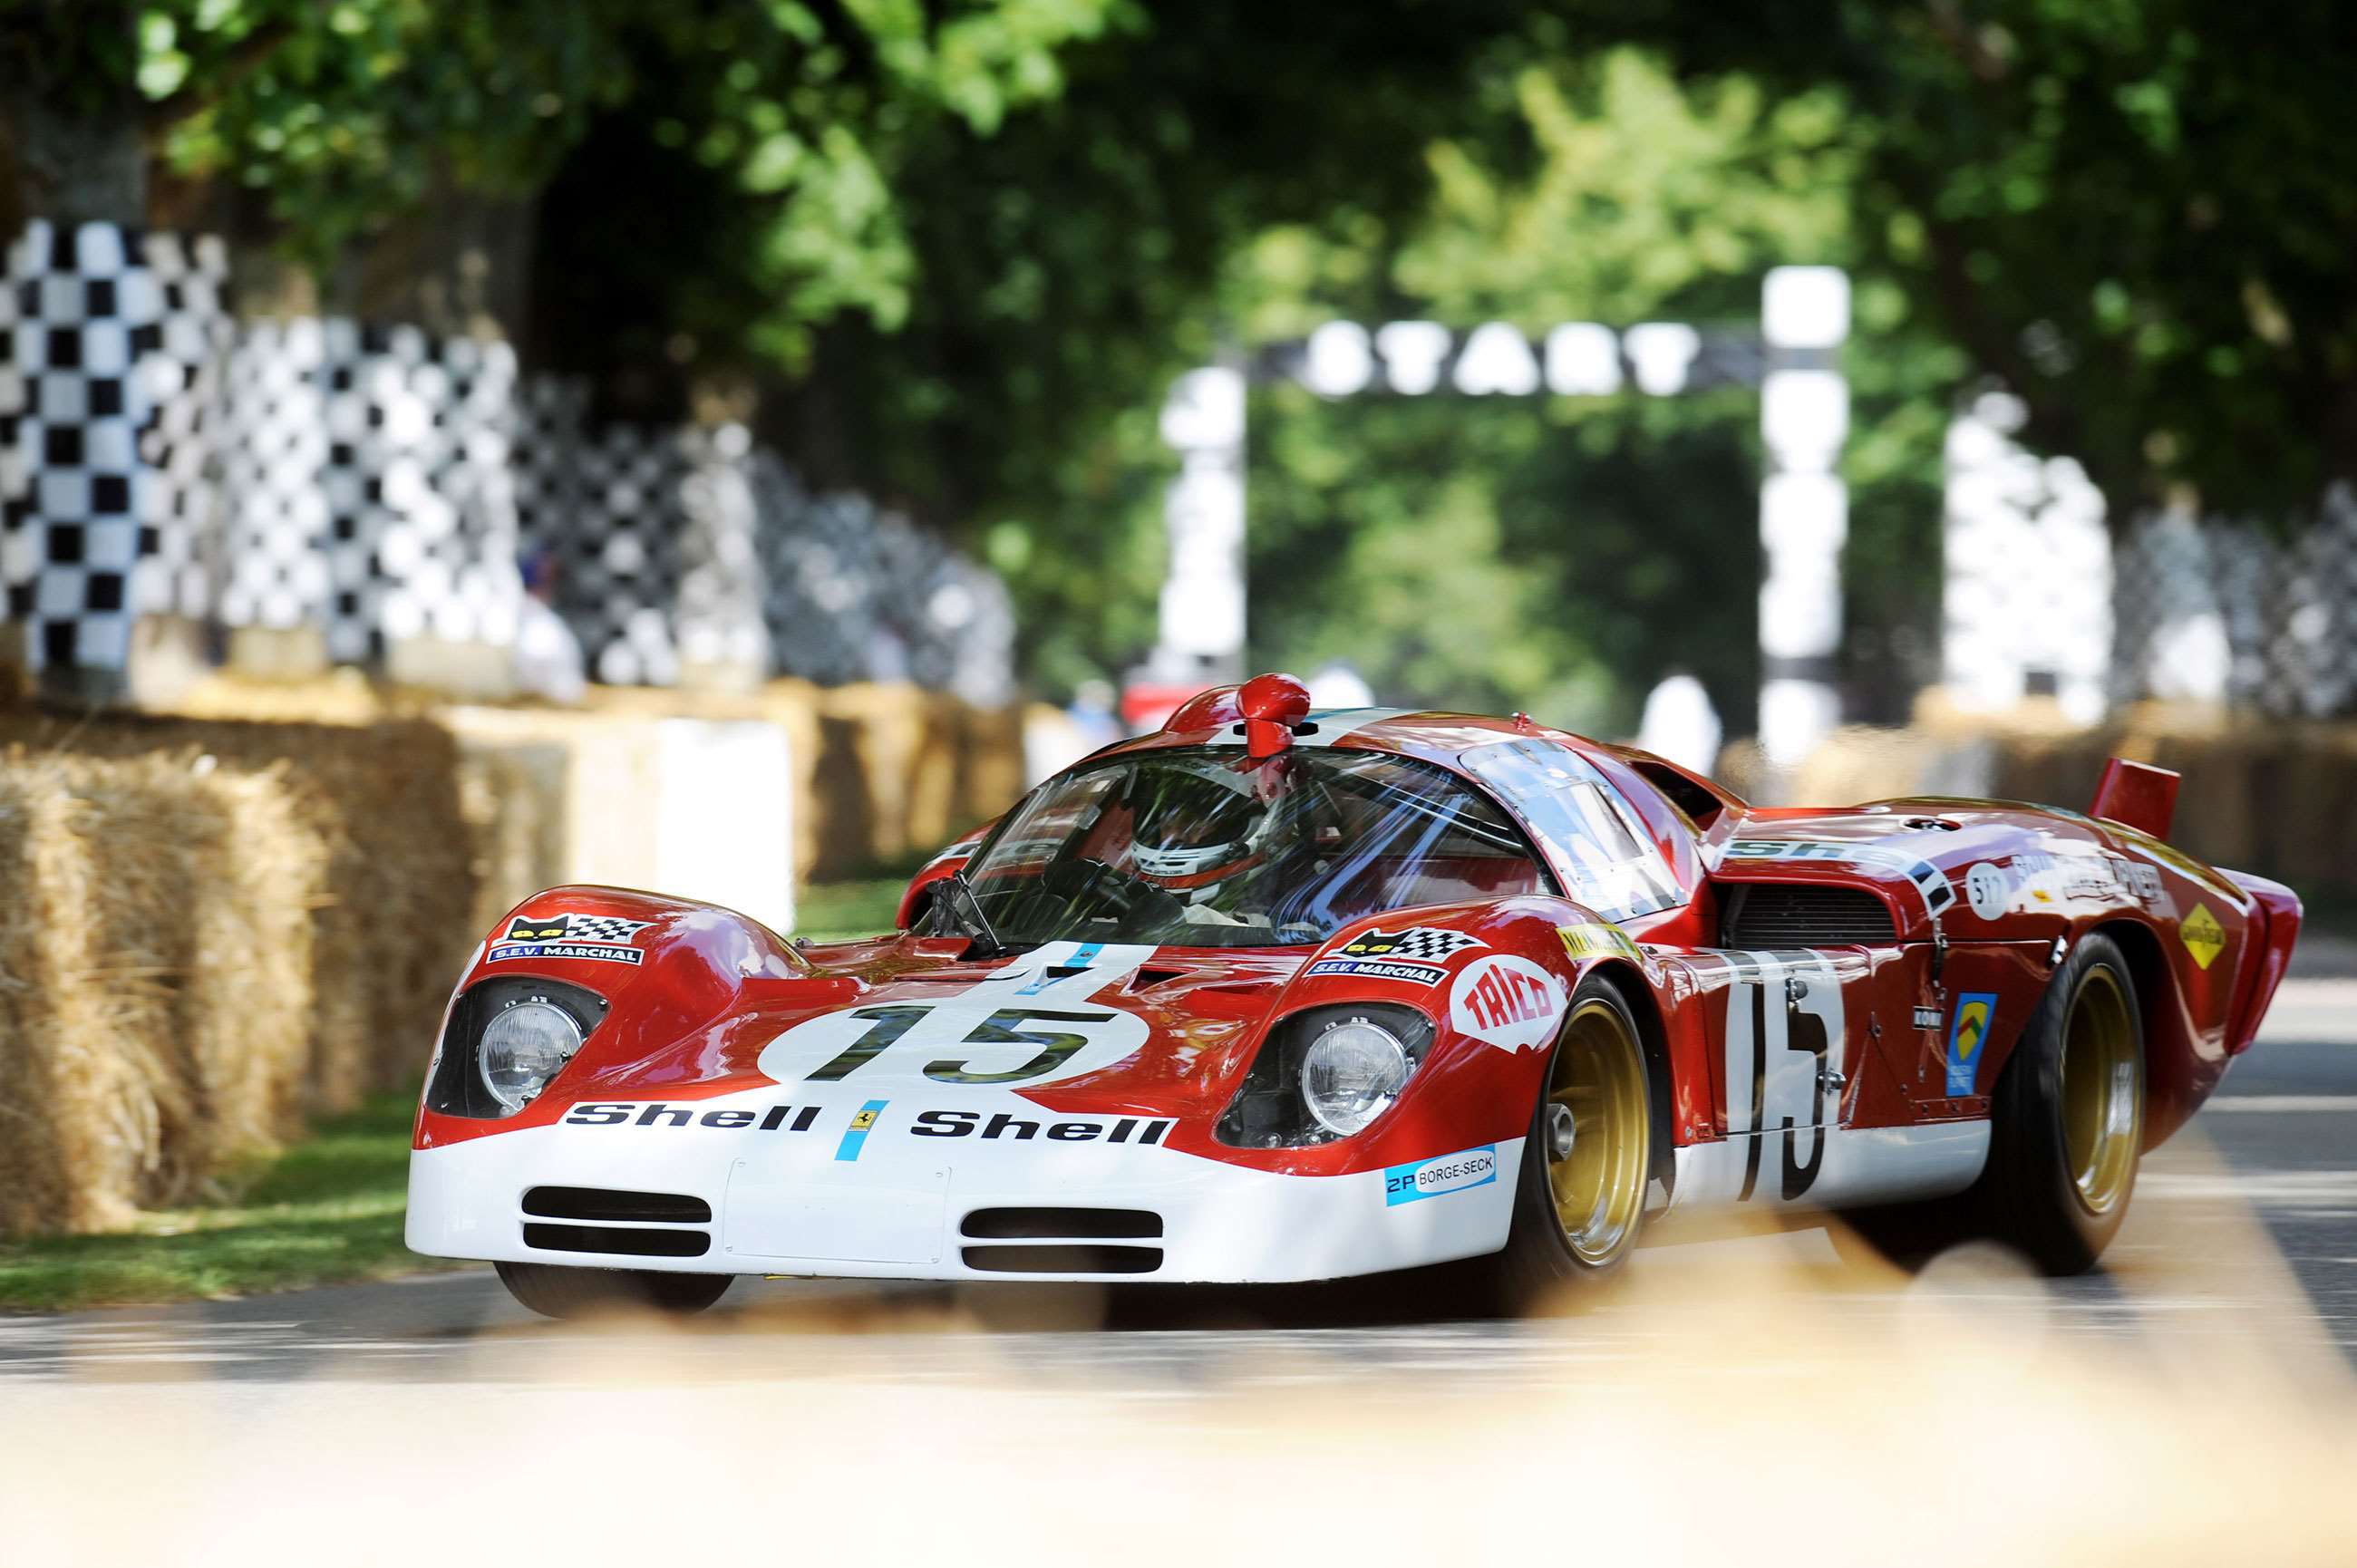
left=0, top=219, right=227, bottom=672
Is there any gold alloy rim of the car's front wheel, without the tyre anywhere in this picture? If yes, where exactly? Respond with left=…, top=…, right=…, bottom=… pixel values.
left=1539, top=997, right=1653, bottom=1266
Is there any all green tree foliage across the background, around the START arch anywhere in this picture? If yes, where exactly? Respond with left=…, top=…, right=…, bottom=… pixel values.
left=32, top=0, right=2357, bottom=724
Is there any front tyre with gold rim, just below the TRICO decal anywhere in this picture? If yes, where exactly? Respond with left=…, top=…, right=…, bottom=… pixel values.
left=1499, top=979, right=1653, bottom=1306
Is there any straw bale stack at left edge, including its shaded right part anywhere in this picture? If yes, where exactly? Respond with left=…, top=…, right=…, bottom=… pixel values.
left=0, top=714, right=474, bottom=1234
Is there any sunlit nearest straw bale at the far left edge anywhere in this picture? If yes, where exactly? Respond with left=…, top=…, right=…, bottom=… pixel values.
left=0, top=750, right=325, bottom=1234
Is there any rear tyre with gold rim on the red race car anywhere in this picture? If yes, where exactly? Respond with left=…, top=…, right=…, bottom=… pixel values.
left=1980, top=936, right=2145, bottom=1275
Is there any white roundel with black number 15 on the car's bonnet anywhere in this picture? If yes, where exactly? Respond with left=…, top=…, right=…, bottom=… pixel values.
left=761, top=941, right=1152, bottom=1094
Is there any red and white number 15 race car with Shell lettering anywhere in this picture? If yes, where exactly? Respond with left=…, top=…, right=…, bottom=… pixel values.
left=408, top=677, right=2301, bottom=1316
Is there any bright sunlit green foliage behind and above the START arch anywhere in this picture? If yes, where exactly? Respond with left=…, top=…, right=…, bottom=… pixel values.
left=1230, top=52, right=1961, bottom=733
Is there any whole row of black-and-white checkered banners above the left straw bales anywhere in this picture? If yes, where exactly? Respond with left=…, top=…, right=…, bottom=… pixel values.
left=0, top=224, right=1014, bottom=705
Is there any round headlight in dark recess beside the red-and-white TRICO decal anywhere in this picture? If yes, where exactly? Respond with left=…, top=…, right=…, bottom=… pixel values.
left=1217, top=1002, right=1438, bottom=1148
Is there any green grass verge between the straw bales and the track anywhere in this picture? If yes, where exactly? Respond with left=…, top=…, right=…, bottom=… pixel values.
left=0, top=875, right=907, bottom=1311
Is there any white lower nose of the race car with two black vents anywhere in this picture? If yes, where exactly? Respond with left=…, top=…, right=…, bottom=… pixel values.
left=408, top=1101, right=1523, bottom=1282
